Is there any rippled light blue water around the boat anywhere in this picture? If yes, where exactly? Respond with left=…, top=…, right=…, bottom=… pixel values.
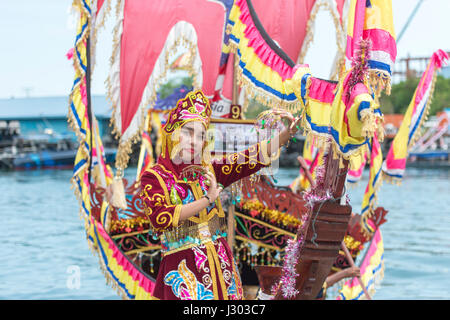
left=0, top=168, right=450, bottom=300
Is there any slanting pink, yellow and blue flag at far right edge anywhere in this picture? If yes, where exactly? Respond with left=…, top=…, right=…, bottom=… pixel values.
left=383, top=50, right=449, bottom=183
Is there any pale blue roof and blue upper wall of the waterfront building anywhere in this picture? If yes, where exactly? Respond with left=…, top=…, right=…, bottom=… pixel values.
left=0, top=96, right=112, bottom=142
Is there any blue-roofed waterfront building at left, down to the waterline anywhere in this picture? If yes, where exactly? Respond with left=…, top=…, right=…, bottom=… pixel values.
left=0, top=96, right=116, bottom=170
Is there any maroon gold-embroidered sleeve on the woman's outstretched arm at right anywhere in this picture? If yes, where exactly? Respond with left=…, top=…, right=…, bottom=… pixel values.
left=212, top=141, right=273, bottom=188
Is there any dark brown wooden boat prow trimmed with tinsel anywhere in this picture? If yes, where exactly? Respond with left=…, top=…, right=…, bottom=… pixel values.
left=255, top=151, right=352, bottom=300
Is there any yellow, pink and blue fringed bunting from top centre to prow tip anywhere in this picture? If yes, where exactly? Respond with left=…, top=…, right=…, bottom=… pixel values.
left=228, top=0, right=382, bottom=159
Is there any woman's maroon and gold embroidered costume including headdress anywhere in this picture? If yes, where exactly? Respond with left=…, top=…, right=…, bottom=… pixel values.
left=141, top=91, right=270, bottom=300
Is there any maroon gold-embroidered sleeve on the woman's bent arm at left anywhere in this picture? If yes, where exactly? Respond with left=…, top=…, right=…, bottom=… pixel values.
left=140, top=170, right=181, bottom=231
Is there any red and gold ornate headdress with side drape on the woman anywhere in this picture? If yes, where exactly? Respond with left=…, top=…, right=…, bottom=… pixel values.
left=161, top=90, right=211, bottom=165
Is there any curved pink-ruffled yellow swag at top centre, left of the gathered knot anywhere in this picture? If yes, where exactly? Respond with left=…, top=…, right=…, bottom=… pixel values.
left=227, top=0, right=309, bottom=111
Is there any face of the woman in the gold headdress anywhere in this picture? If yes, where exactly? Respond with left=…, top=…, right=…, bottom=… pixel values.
left=179, top=121, right=206, bottom=163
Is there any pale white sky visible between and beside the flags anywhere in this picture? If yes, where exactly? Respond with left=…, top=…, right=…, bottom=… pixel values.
left=0, top=0, right=450, bottom=98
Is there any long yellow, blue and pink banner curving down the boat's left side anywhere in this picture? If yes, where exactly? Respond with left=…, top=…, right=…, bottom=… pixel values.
left=68, top=0, right=154, bottom=299
